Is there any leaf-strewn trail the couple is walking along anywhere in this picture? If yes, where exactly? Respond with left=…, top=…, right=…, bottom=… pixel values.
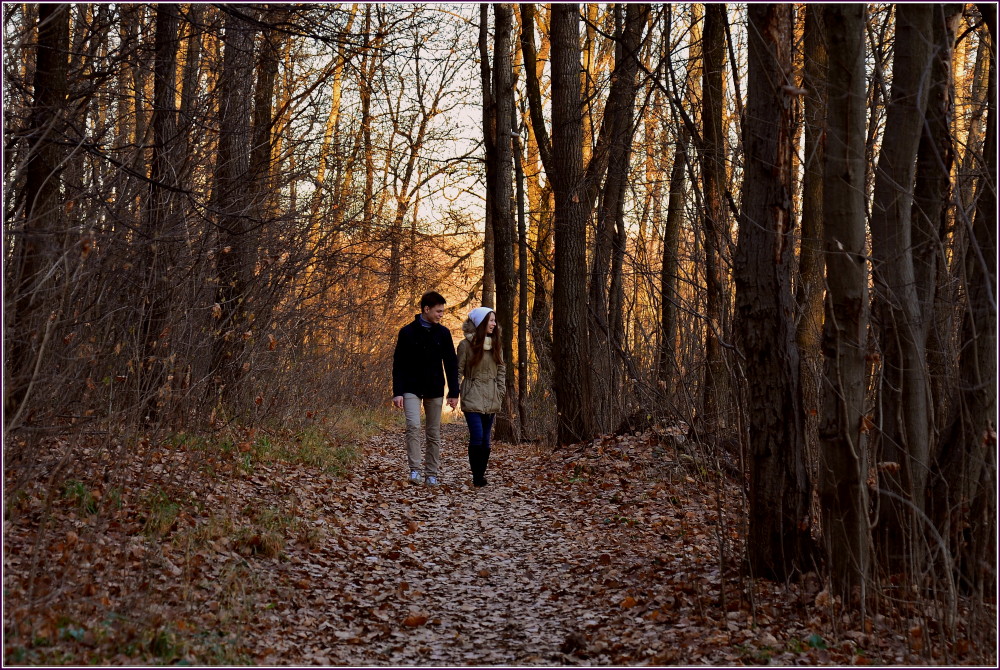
left=248, top=425, right=704, bottom=665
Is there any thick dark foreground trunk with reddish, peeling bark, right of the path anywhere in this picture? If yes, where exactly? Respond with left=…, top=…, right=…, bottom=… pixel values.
left=734, top=4, right=813, bottom=580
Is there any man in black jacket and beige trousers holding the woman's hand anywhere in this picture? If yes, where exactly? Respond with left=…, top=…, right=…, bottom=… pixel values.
left=392, top=291, right=459, bottom=486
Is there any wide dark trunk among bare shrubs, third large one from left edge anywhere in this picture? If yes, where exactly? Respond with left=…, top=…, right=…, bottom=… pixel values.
left=212, top=7, right=256, bottom=397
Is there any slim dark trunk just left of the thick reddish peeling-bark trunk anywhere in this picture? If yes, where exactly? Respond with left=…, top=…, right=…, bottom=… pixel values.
left=699, top=4, right=729, bottom=432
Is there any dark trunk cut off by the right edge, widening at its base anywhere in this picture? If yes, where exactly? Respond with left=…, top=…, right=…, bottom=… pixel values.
left=932, top=3, right=997, bottom=598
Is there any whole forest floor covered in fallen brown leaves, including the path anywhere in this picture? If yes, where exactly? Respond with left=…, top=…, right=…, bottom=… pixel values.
left=4, top=424, right=996, bottom=666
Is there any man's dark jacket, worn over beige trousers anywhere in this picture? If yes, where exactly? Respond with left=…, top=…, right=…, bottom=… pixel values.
left=392, top=314, right=459, bottom=398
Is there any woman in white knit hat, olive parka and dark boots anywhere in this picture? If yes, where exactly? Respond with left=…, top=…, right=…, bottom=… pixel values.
left=458, top=307, right=507, bottom=486
